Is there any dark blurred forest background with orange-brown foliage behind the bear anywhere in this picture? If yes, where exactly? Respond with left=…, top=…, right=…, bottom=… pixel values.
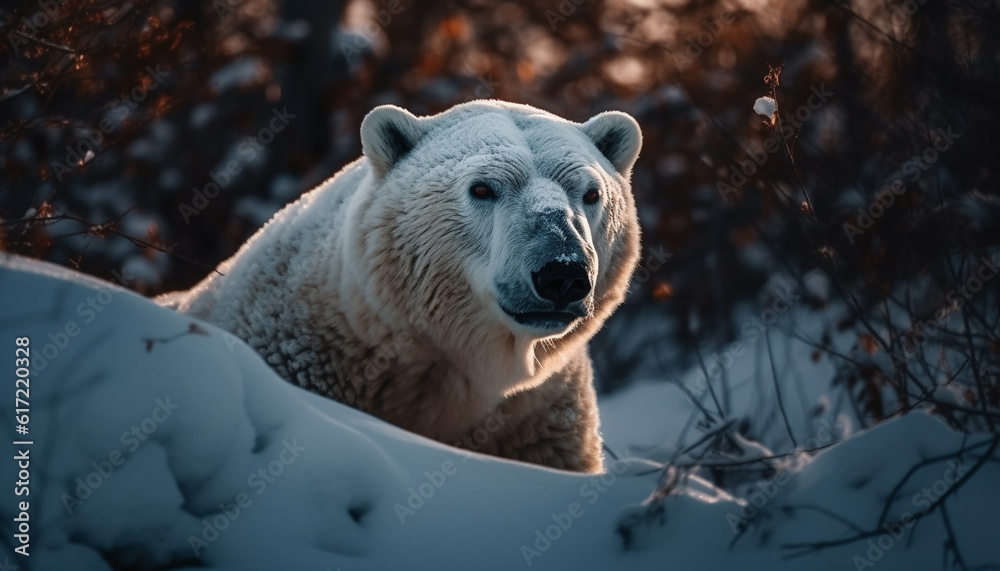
left=0, top=0, right=1000, bottom=438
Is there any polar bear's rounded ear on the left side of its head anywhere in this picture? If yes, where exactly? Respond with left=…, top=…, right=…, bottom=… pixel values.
left=361, top=105, right=424, bottom=176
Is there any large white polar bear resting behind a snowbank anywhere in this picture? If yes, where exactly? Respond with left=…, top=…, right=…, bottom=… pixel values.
left=157, top=101, right=642, bottom=472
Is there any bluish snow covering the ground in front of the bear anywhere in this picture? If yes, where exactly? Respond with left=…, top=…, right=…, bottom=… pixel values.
left=0, top=257, right=1000, bottom=571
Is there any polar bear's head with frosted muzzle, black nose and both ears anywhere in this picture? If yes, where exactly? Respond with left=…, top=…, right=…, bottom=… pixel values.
left=347, top=101, right=642, bottom=399
